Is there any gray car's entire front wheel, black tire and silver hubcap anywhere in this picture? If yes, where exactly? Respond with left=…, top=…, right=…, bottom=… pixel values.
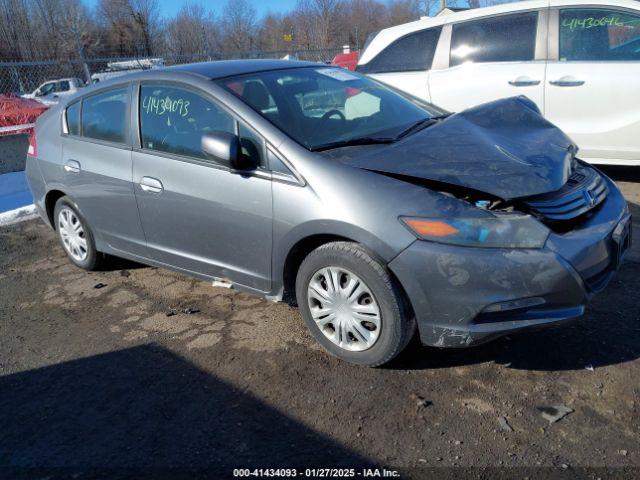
left=296, top=242, right=415, bottom=367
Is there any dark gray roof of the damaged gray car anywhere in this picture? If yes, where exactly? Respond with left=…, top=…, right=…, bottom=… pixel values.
left=170, top=59, right=323, bottom=79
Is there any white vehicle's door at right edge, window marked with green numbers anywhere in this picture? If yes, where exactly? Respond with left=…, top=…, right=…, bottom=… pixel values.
left=545, top=6, right=640, bottom=164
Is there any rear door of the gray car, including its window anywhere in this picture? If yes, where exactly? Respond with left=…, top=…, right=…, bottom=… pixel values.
left=62, top=84, right=146, bottom=256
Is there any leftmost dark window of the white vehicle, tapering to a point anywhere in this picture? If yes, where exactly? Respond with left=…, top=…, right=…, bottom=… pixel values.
left=357, top=28, right=441, bottom=73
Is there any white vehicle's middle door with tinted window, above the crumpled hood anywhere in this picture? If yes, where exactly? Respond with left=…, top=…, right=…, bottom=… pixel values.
left=429, top=9, right=548, bottom=112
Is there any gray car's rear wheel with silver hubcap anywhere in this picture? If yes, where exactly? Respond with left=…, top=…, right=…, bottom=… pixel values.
left=54, top=196, right=102, bottom=270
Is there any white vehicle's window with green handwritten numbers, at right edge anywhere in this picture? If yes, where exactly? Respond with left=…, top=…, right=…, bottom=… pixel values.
left=560, top=8, right=640, bottom=61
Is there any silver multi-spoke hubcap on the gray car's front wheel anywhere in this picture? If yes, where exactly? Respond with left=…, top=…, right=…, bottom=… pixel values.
left=307, top=266, right=382, bottom=352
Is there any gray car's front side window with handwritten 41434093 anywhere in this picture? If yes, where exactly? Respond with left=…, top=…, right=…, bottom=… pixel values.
left=140, top=85, right=235, bottom=160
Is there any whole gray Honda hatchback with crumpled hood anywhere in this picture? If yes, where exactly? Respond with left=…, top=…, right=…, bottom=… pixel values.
left=26, top=60, right=631, bottom=366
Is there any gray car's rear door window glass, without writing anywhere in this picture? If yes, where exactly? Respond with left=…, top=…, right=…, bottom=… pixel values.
left=82, top=87, right=129, bottom=143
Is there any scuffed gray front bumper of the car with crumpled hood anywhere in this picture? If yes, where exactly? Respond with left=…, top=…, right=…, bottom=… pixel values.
left=389, top=174, right=631, bottom=347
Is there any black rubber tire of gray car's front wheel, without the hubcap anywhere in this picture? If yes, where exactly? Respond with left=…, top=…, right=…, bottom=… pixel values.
left=296, top=242, right=416, bottom=367
